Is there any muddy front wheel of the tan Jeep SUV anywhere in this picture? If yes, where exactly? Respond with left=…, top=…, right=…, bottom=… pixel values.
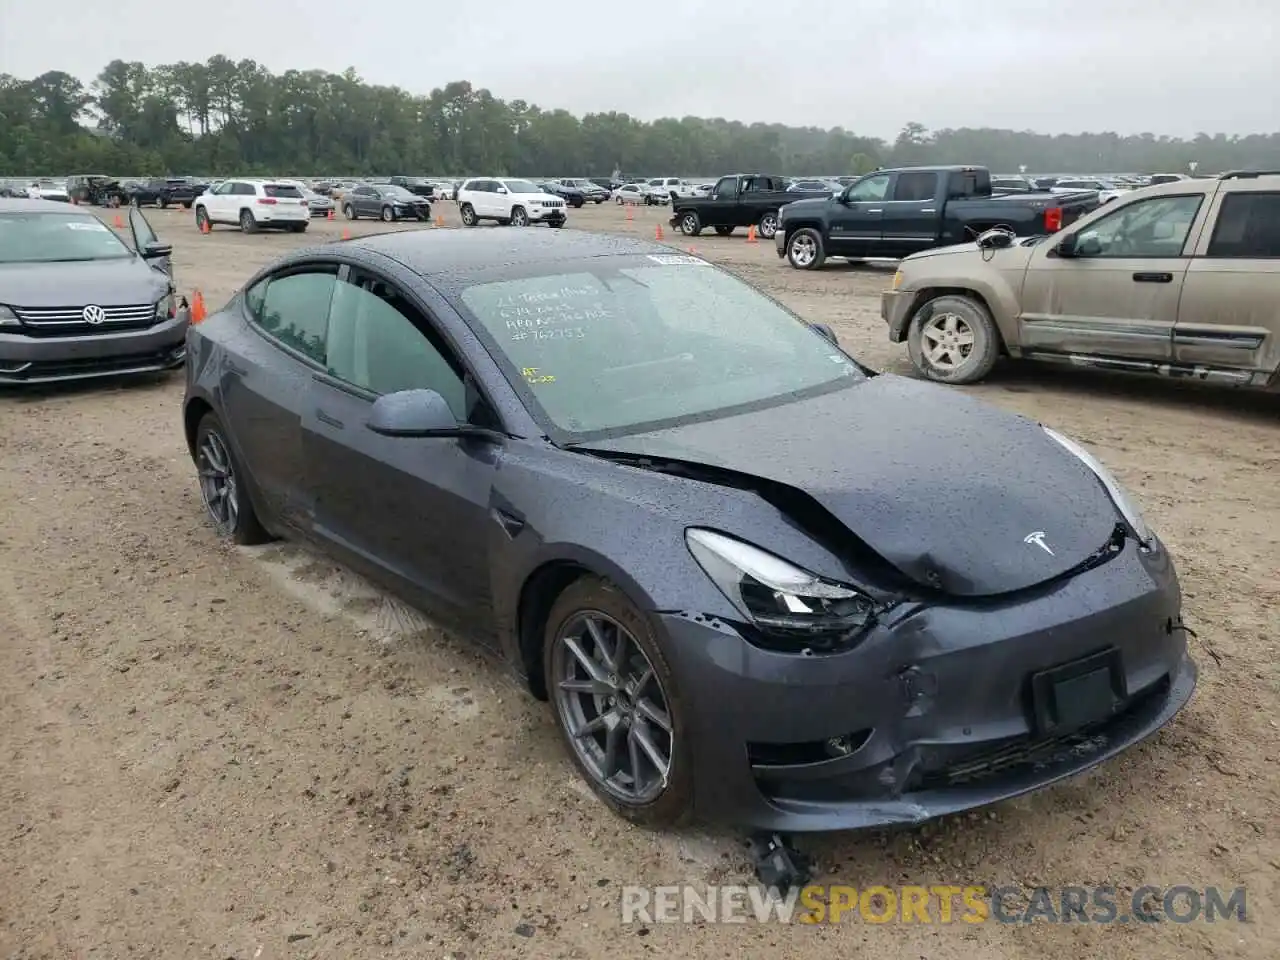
left=906, top=296, right=1000, bottom=384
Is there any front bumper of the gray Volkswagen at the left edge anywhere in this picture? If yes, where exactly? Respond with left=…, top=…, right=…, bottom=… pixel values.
left=0, top=310, right=191, bottom=385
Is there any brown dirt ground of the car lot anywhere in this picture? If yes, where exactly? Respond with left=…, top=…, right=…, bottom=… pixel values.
left=0, top=202, right=1280, bottom=960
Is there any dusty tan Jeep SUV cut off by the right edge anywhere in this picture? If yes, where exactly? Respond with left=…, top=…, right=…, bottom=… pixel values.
left=881, top=172, right=1280, bottom=389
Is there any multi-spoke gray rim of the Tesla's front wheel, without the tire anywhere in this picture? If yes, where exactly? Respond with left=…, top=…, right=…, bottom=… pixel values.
left=552, top=611, right=672, bottom=804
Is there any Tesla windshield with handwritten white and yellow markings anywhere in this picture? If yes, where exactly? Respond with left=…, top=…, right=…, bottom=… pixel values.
left=461, top=255, right=861, bottom=438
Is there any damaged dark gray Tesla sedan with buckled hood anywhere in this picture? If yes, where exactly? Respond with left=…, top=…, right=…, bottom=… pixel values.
left=184, top=230, right=1196, bottom=831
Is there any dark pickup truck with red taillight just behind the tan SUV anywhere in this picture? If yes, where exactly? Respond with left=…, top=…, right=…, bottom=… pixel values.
left=773, top=166, right=1100, bottom=270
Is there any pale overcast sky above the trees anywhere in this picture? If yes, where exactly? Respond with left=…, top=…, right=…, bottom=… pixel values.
left=0, top=0, right=1280, bottom=138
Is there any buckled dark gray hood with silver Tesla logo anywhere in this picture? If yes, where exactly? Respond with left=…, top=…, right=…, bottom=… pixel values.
left=582, top=375, right=1120, bottom=596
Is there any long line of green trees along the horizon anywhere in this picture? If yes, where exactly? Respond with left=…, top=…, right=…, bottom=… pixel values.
left=0, top=55, right=1280, bottom=177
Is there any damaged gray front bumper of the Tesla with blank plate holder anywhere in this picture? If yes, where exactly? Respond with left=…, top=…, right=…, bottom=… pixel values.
left=657, top=543, right=1197, bottom=832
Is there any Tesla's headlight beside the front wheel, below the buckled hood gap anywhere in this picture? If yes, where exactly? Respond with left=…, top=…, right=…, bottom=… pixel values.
left=685, top=527, right=878, bottom=649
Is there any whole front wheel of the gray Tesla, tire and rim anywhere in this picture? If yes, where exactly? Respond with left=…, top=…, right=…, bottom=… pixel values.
left=543, top=577, right=694, bottom=827
